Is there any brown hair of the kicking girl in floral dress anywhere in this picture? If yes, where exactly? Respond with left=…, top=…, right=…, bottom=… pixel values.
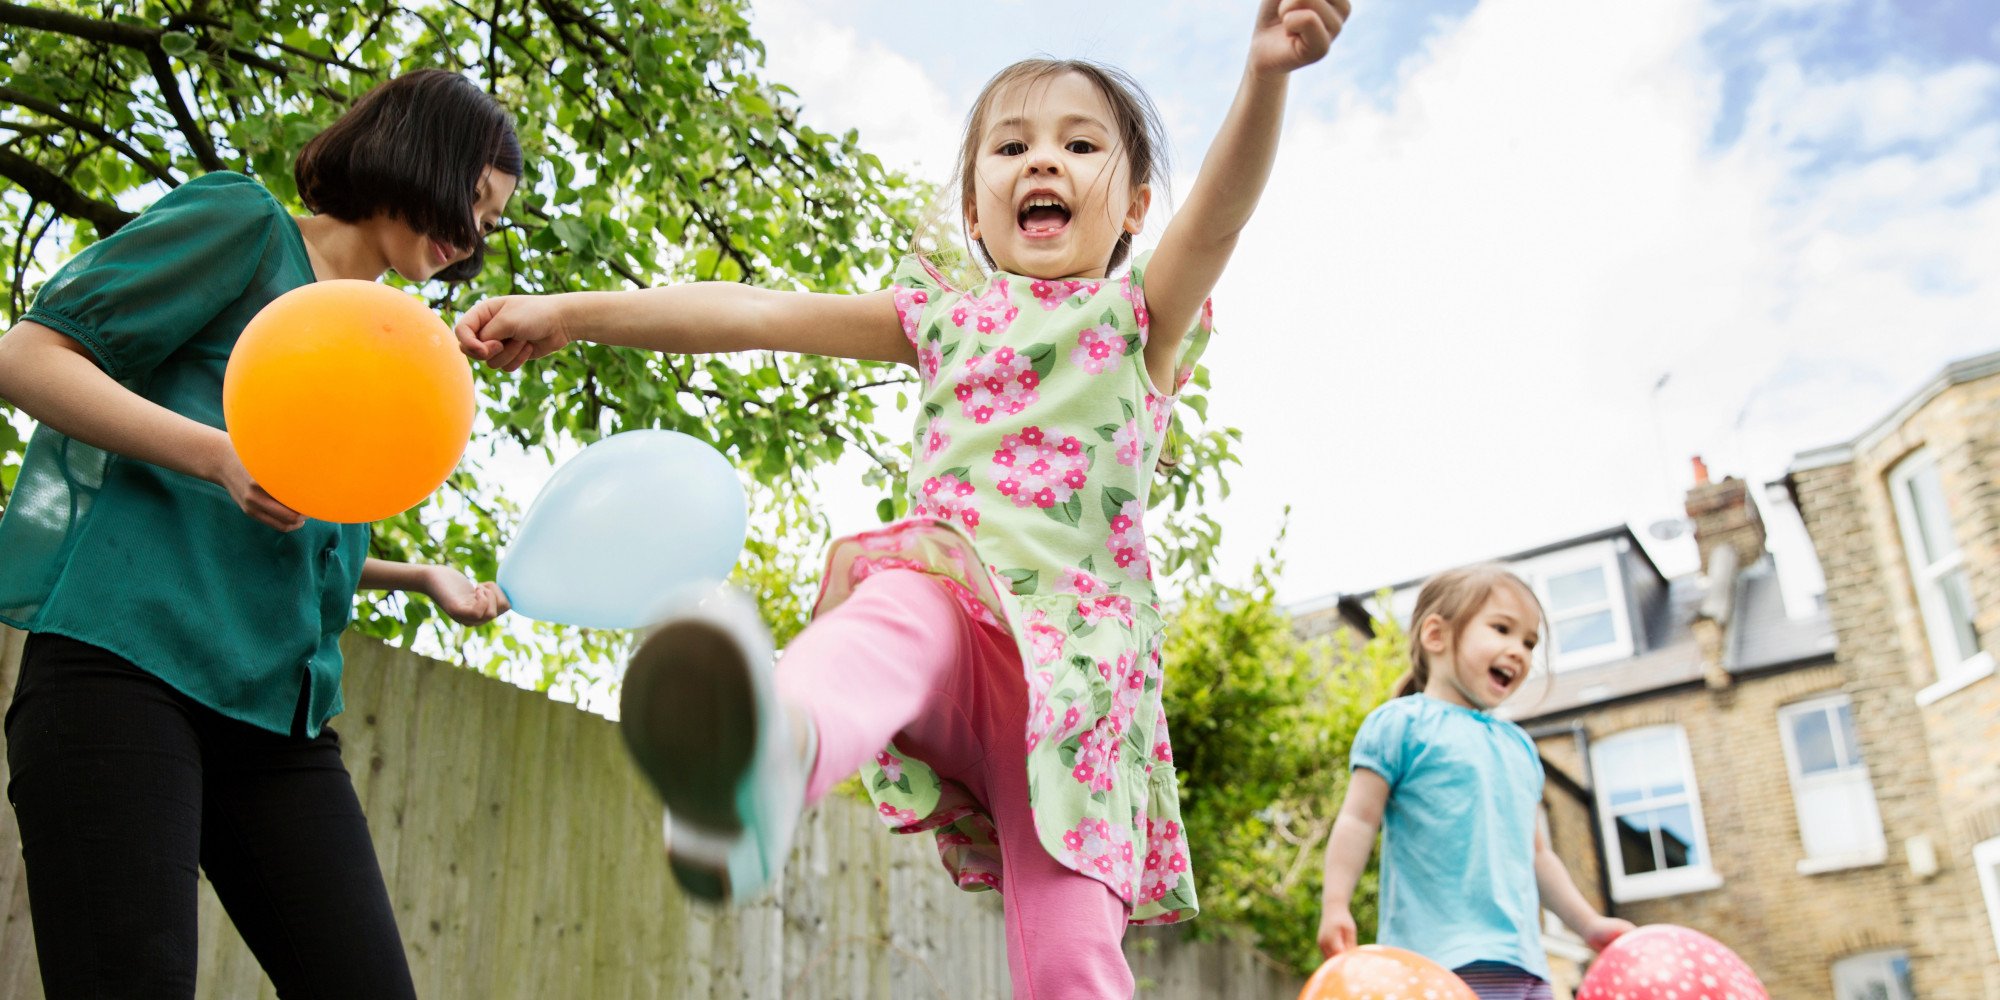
left=958, top=60, right=1168, bottom=270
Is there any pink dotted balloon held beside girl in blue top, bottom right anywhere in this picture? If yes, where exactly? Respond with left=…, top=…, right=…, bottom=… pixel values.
left=1576, top=924, right=1770, bottom=1000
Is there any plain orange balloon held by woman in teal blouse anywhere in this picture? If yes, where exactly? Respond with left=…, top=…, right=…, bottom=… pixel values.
left=222, top=278, right=474, bottom=524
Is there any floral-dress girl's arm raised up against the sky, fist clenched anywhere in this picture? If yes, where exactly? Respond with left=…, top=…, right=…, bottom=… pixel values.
left=1146, top=0, right=1352, bottom=386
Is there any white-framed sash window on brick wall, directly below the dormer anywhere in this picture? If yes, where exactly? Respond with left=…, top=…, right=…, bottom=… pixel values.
left=1590, top=726, right=1722, bottom=902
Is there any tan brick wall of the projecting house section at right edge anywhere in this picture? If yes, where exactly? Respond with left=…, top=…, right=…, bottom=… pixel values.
left=1794, top=376, right=2000, bottom=1000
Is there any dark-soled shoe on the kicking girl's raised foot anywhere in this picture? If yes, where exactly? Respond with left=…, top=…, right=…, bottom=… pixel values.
left=618, top=590, right=806, bottom=902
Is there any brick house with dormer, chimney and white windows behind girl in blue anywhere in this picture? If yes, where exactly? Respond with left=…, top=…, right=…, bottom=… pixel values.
left=1294, top=354, right=2000, bottom=1000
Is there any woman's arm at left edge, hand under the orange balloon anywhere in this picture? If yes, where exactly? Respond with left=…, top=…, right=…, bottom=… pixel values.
left=0, top=320, right=306, bottom=532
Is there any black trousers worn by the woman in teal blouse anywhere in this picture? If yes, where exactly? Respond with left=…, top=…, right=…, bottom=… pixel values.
left=6, top=634, right=416, bottom=1000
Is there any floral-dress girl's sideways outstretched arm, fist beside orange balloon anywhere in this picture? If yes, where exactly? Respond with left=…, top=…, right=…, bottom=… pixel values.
left=454, top=282, right=916, bottom=372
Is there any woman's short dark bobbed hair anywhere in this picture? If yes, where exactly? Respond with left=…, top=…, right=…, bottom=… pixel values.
left=292, top=70, right=522, bottom=282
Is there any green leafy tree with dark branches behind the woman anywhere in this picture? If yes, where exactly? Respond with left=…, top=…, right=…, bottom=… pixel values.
left=0, top=0, right=1236, bottom=686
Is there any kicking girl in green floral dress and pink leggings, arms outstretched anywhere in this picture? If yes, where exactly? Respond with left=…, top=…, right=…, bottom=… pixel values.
left=458, top=0, right=1348, bottom=996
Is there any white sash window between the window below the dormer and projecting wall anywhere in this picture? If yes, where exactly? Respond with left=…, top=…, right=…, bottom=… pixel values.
left=1778, top=694, right=1888, bottom=874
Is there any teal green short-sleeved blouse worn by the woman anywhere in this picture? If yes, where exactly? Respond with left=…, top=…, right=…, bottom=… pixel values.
left=0, top=172, right=368, bottom=736
